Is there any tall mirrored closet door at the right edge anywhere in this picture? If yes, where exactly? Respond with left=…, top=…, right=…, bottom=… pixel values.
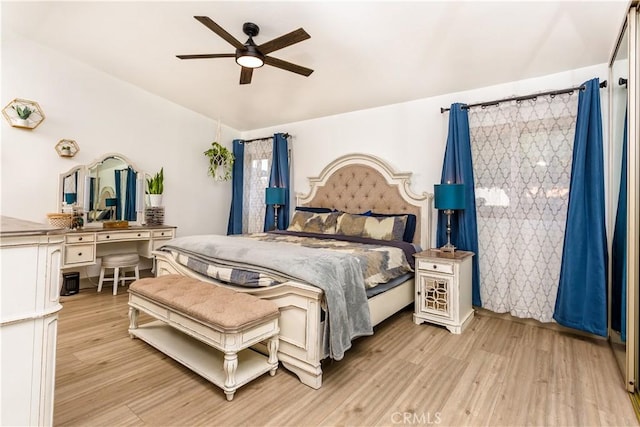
left=609, top=1, right=640, bottom=413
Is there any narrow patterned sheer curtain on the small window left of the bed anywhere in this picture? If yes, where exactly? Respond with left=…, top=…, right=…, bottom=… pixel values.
left=242, top=139, right=273, bottom=234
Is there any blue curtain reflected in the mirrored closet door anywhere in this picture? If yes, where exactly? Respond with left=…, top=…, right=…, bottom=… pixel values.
left=611, top=109, right=627, bottom=341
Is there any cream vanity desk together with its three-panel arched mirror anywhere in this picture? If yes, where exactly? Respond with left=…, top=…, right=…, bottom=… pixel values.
left=58, top=153, right=176, bottom=269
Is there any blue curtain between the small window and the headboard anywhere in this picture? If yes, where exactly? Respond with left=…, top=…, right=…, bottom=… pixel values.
left=264, top=133, right=291, bottom=231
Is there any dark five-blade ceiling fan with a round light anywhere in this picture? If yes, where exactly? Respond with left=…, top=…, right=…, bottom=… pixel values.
left=176, top=16, right=313, bottom=85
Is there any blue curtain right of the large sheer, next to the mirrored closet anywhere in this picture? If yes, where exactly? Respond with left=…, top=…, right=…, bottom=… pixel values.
left=553, top=79, right=607, bottom=336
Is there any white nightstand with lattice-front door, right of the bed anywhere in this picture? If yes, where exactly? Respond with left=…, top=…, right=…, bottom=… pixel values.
left=413, top=249, right=474, bottom=334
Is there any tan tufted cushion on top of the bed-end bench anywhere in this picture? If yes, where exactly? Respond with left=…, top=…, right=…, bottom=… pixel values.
left=129, top=274, right=279, bottom=330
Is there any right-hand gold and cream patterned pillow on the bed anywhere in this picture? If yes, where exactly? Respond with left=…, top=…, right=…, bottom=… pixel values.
left=336, top=213, right=407, bottom=241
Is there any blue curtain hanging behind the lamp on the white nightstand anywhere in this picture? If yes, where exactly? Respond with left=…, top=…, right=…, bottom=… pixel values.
left=436, top=103, right=482, bottom=307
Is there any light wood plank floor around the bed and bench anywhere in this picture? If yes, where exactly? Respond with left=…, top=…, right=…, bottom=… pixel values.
left=54, top=289, right=638, bottom=426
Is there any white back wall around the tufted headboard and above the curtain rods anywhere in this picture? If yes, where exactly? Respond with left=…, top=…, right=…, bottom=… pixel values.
left=242, top=64, right=608, bottom=246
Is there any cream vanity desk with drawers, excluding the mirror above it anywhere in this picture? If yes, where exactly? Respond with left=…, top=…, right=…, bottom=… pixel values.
left=62, top=225, right=176, bottom=268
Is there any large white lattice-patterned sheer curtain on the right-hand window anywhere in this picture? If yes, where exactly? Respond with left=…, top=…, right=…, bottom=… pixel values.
left=469, top=94, right=578, bottom=322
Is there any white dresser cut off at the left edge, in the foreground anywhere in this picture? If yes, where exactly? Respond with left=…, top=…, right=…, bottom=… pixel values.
left=0, top=216, right=65, bottom=426
